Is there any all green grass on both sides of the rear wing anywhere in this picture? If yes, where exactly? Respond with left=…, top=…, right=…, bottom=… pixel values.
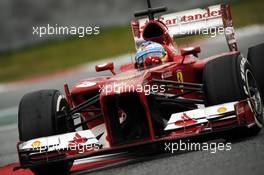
left=0, top=0, right=264, bottom=82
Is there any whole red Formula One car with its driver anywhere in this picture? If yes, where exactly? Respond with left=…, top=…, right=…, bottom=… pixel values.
left=17, top=1, right=264, bottom=174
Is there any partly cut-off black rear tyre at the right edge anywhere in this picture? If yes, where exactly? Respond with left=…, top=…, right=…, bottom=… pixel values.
left=248, top=43, right=264, bottom=102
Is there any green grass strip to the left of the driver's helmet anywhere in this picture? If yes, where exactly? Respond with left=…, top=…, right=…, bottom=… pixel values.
left=0, top=27, right=134, bottom=82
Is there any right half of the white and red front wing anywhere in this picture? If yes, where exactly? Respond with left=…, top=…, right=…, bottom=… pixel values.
left=165, top=100, right=255, bottom=136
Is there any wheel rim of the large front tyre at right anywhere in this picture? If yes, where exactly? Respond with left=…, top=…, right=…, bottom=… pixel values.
left=246, top=69, right=263, bottom=127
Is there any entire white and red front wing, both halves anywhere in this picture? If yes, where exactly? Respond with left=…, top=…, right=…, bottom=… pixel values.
left=17, top=100, right=255, bottom=171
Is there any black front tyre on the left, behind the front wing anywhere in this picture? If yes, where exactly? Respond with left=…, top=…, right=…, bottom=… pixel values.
left=18, top=90, right=74, bottom=174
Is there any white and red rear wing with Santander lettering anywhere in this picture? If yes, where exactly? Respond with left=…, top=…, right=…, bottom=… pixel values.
left=131, top=4, right=237, bottom=51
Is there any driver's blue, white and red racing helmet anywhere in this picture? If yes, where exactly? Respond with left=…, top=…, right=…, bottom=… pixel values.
left=135, top=41, right=168, bottom=69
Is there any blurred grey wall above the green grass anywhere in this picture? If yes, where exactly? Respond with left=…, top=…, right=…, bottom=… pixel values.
left=0, top=0, right=229, bottom=51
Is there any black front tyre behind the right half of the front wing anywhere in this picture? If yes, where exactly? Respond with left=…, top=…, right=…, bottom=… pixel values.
left=203, top=55, right=263, bottom=135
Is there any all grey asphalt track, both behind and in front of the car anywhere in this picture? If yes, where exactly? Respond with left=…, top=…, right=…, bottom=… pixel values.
left=0, top=26, right=264, bottom=174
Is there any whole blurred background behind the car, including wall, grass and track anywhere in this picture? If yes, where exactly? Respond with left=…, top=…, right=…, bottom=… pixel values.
left=0, top=0, right=264, bottom=170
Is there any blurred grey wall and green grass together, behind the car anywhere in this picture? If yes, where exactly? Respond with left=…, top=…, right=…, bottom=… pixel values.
left=0, top=0, right=264, bottom=82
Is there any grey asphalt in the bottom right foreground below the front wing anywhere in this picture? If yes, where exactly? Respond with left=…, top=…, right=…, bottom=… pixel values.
left=86, top=131, right=264, bottom=175
